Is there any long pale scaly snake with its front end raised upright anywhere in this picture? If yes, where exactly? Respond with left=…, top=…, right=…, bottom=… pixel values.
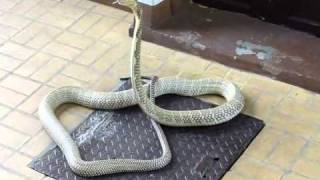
left=39, top=0, right=244, bottom=176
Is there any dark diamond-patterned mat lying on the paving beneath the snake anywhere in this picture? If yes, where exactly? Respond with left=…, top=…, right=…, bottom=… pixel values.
left=30, top=82, right=264, bottom=180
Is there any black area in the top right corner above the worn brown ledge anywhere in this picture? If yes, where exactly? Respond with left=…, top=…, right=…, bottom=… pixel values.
left=193, top=0, right=320, bottom=37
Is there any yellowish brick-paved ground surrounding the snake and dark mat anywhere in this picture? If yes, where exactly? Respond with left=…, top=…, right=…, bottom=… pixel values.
left=0, top=0, right=320, bottom=180
